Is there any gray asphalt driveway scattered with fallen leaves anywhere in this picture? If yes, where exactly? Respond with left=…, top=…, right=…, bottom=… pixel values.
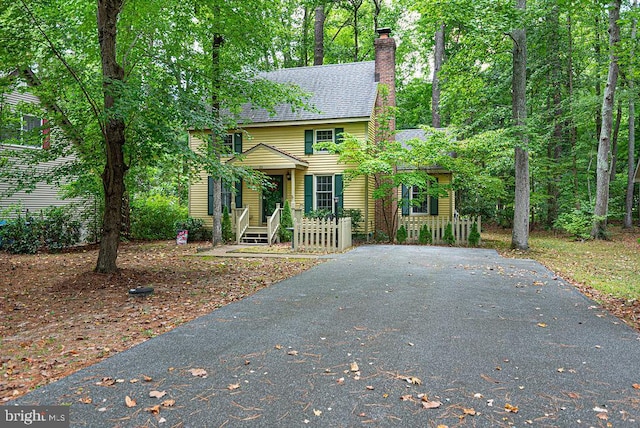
left=10, top=246, right=640, bottom=427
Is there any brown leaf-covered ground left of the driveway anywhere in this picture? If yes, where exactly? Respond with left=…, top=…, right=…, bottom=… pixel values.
left=0, top=241, right=318, bottom=404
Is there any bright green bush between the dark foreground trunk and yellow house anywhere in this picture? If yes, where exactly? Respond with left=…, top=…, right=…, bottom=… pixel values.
left=131, top=195, right=188, bottom=240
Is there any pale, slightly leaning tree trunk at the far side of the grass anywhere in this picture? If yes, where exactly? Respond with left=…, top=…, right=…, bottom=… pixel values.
left=591, top=0, right=621, bottom=239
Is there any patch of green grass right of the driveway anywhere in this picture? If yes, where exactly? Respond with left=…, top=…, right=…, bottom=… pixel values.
left=482, top=226, right=640, bottom=299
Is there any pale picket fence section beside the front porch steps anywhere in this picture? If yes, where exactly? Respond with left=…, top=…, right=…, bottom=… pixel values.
left=292, top=210, right=353, bottom=253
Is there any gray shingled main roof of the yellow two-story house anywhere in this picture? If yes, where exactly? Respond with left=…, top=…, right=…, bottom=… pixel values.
left=241, top=61, right=377, bottom=125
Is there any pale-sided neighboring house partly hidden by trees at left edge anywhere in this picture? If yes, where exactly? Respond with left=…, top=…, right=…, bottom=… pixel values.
left=0, top=83, right=95, bottom=237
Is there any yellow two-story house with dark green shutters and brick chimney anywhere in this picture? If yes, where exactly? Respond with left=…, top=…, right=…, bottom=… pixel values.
left=189, top=29, right=454, bottom=246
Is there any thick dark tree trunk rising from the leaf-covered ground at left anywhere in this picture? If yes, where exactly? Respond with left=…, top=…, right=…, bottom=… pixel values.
left=95, top=0, right=127, bottom=273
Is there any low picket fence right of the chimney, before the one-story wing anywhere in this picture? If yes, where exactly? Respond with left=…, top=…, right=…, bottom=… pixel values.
left=398, top=216, right=482, bottom=245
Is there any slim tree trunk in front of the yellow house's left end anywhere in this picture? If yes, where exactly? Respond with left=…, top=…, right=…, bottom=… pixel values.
left=211, top=34, right=224, bottom=247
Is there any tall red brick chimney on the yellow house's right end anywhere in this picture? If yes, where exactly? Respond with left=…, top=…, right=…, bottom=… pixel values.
left=374, top=28, right=398, bottom=241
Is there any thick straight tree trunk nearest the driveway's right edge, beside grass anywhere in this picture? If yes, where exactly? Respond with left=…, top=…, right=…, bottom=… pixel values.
left=511, top=0, right=531, bottom=250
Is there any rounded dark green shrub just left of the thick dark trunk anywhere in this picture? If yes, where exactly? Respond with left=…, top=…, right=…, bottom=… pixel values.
left=41, top=207, right=82, bottom=252
